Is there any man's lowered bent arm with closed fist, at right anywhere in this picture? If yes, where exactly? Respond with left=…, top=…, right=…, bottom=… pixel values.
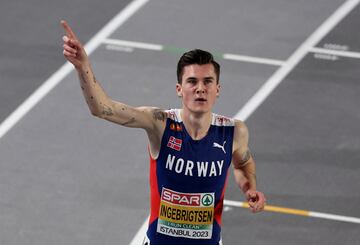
left=232, top=121, right=266, bottom=212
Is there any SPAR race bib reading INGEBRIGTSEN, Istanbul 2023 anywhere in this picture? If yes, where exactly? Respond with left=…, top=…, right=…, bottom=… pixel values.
left=157, top=187, right=215, bottom=239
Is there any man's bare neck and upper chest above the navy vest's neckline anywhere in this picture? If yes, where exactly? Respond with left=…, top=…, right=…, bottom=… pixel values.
left=181, top=110, right=212, bottom=140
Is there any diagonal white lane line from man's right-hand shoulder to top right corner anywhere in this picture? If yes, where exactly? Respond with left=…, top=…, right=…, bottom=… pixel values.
left=234, top=0, right=360, bottom=121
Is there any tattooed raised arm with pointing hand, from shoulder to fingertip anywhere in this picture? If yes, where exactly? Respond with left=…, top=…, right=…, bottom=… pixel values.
left=61, top=20, right=167, bottom=156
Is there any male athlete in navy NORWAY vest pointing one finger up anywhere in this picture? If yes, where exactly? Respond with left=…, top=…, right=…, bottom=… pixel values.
left=61, top=21, right=265, bottom=245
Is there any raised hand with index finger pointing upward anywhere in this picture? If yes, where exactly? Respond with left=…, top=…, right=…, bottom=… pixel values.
left=61, top=20, right=88, bottom=68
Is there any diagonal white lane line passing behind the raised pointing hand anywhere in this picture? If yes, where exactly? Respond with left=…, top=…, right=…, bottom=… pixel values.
left=0, top=0, right=149, bottom=139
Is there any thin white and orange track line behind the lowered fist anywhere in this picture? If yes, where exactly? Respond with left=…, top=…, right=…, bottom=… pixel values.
left=224, top=200, right=360, bottom=224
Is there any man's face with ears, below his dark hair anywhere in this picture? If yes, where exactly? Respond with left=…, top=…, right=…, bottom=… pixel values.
left=176, top=64, right=220, bottom=113
